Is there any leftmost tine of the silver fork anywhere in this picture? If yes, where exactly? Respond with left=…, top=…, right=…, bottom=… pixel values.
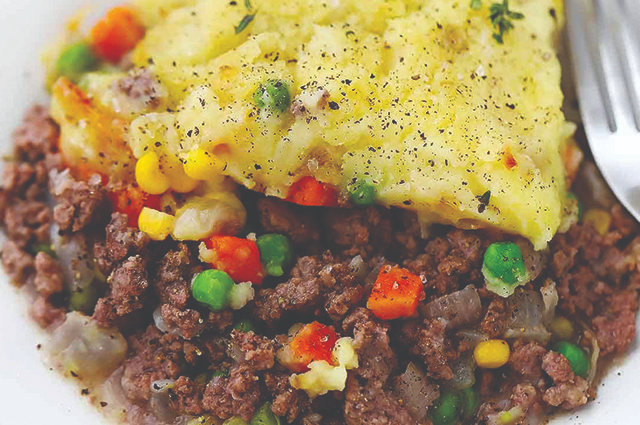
left=566, top=0, right=615, bottom=132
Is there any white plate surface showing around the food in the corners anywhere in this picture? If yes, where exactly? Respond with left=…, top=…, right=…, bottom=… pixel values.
left=0, top=0, right=640, bottom=425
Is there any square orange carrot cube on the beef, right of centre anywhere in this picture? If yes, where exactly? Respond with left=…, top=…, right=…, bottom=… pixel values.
left=367, top=266, right=424, bottom=320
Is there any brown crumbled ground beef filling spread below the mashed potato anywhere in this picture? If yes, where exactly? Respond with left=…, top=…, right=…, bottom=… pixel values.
left=0, top=107, right=640, bottom=425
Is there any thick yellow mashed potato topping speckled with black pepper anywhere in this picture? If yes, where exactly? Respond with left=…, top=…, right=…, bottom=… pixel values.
left=54, top=0, right=573, bottom=248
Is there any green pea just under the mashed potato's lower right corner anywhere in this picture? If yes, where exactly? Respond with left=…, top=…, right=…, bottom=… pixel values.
left=483, top=242, right=527, bottom=285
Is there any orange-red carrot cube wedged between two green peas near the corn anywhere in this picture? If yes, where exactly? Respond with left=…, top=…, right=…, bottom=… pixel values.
left=205, top=236, right=264, bottom=285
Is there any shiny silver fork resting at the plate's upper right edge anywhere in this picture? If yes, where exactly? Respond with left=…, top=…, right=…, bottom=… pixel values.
left=565, top=0, right=640, bottom=220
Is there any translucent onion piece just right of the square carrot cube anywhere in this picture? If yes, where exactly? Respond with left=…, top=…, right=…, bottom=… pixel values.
left=424, top=285, right=482, bottom=329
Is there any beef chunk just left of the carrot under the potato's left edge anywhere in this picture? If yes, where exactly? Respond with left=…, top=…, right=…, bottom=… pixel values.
left=53, top=176, right=110, bottom=232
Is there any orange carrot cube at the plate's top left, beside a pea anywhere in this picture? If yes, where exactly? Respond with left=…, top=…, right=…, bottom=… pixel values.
left=90, top=7, right=145, bottom=63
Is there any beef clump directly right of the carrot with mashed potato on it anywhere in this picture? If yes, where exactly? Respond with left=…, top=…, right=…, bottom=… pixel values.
left=343, top=308, right=397, bottom=387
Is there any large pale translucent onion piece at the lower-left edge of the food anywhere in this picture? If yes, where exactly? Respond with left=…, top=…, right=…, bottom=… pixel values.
left=49, top=312, right=127, bottom=383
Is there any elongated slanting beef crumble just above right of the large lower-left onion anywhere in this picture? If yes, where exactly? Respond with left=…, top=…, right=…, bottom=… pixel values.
left=93, top=256, right=149, bottom=326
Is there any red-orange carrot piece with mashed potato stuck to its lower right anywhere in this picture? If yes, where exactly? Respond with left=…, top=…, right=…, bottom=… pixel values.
left=287, top=322, right=338, bottom=372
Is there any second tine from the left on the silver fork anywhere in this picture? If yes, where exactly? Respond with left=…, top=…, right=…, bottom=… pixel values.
left=595, top=0, right=638, bottom=131
